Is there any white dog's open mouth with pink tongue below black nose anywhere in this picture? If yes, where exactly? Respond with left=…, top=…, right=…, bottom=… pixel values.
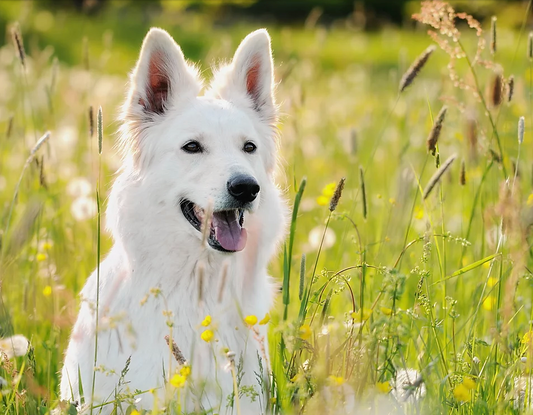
left=180, top=199, right=247, bottom=252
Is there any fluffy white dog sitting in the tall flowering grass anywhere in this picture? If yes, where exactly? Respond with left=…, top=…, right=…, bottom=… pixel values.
left=61, top=29, right=286, bottom=414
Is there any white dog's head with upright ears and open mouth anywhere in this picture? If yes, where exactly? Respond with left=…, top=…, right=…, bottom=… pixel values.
left=117, top=29, right=277, bottom=252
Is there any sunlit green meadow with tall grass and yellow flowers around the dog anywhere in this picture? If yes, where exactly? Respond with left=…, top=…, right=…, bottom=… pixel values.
left=0, top=1, right=533, bottom=414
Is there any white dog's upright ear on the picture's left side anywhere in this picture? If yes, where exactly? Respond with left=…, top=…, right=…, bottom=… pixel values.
left=124, top=28, right=201, bottom=120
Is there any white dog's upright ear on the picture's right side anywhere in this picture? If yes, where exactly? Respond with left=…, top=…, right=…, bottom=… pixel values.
left=212, top=29, right=277, bottom=124
